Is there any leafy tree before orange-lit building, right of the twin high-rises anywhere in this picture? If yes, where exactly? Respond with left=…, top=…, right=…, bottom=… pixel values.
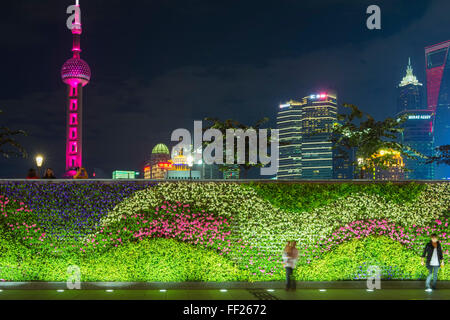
left=331, top=104, right=425, bottom=179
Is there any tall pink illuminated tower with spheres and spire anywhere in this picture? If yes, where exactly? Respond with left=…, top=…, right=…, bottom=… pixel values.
left=61, top=0, right=91, bottom=177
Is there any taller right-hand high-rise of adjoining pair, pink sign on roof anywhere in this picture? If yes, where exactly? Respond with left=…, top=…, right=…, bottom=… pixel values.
left=302, top=92, right=338, bottom=180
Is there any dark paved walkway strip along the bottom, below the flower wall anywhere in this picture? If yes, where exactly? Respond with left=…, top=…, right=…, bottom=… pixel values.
left=0, top=289, right=450, bottom=300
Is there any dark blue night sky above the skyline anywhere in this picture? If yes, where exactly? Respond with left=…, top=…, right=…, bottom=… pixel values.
left=0, top=0, right=450, bottom=178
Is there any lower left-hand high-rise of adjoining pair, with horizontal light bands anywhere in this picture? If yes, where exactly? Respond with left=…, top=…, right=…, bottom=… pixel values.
left=277, top=100, right=303, bottom=179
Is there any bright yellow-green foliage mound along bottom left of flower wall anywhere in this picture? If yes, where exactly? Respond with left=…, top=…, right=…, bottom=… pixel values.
left=0, top=239, right=249, bottom=282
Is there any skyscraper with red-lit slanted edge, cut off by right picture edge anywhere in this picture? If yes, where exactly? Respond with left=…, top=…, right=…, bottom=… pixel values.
left=425, top=41, right=450, bottom=179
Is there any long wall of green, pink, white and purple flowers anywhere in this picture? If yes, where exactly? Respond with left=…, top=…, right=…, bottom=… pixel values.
left=0, top=182, right=450, bottom=281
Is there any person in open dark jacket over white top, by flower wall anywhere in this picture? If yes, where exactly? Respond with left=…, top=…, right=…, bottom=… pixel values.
left=422, top=233, right=444, bottom=291
